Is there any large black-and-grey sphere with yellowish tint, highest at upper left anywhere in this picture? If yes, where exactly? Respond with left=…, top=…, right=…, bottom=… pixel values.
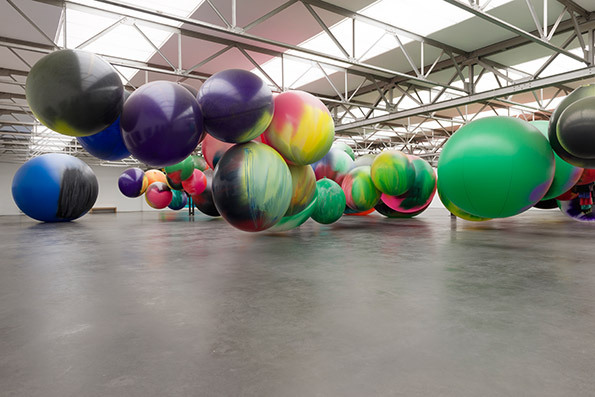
left=26, top=50, right=124, bottom=136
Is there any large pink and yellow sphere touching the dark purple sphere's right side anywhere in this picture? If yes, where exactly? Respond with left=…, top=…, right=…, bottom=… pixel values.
left=263, top=91, right=335, bottom=165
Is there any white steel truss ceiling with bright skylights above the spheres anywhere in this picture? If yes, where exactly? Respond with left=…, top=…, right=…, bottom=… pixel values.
left=0, top=0, right=595, bottom=165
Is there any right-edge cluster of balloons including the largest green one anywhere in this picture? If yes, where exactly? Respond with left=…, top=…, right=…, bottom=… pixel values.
left=438, top=85, right=595, bottom=221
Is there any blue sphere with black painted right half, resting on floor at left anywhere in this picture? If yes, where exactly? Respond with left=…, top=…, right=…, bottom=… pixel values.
left=12, top=153, right=99, bottom=222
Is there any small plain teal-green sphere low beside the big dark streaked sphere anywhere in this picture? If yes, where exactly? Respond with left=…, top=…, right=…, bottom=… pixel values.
left=312, top=178, right=345, bottom=225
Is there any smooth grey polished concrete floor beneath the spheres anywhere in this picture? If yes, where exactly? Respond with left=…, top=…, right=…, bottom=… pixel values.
left=0, top=209, right=595, bottom=397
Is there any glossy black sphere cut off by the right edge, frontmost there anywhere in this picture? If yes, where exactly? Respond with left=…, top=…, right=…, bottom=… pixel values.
left=556, top=96, right=595, bottom=168
